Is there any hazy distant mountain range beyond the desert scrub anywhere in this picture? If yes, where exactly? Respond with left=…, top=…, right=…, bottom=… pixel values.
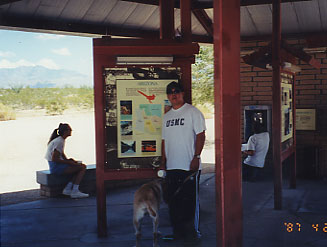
left=0, top=66, right=93, bottom=88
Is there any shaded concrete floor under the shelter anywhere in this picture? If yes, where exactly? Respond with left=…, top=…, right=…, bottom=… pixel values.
left=0, top=173, right=327, bottom=247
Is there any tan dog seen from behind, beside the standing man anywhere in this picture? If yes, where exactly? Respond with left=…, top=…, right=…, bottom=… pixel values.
left=133, top=179, right=162, bottom=247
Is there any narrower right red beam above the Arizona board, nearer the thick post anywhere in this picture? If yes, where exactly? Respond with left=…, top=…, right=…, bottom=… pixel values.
left=180, top=0, right=192, bottom=42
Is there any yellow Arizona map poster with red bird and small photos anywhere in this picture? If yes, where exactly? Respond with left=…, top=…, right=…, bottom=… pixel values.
left=117, top=79, right=173, bottom=158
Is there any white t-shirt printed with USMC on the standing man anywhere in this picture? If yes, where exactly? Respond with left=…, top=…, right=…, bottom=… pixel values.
left=162, top=103, right=206, bottom=171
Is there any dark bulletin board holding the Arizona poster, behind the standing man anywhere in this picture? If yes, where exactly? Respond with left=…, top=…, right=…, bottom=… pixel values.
left=104, top=67, right=181, bottom=170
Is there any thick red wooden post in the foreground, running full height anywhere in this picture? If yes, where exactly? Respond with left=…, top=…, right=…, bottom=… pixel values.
left=214, top=0, right=243, bottom=247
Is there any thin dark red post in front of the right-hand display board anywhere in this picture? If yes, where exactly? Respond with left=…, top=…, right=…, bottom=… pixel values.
left=272, top=0, right=282, bottom=209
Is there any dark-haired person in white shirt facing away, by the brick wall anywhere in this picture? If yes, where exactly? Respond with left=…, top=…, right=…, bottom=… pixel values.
left=243, top=121, right=269, bottom=181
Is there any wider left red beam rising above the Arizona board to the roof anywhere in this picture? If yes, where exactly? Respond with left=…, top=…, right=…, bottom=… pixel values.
left=159, top=0, right=175, bottom=39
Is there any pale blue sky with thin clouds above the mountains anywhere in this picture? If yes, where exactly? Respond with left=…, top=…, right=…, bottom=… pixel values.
left=0, top=30, right=93, bottom=76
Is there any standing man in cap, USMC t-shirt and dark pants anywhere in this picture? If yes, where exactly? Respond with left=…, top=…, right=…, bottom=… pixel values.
left=161, top=82, right=206, bottom=240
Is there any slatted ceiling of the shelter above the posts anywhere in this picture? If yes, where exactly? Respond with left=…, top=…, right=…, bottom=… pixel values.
left=0, top=0, right=327, bottom=42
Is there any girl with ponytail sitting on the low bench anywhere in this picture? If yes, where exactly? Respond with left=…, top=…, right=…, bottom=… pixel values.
left=45, top=123, right=89, bottom=198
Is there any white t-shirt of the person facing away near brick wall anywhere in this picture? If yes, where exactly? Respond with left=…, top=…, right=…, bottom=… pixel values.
left=244, top=132, right=269, bottom=168
